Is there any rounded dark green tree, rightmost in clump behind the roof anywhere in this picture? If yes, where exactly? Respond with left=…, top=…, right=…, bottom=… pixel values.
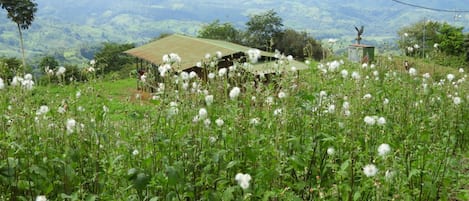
left=274, top=29, right=322, bottom=60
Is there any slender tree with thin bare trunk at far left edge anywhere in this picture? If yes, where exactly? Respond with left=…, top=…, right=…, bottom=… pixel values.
left=0, top=0, right=37, bottom=72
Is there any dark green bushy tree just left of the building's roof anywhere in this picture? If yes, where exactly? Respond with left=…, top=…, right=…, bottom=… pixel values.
left=94, top=42, right=135, bottom=73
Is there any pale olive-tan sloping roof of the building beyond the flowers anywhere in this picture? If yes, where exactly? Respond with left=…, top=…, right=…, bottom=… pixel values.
left=124, top=34, right=308, bottom=72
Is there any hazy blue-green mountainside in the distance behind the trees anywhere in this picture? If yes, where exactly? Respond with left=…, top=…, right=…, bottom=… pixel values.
left=0, top=0, right=469, bottom=63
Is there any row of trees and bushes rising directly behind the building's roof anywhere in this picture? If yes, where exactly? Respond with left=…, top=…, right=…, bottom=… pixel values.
left=198, top=10, right=325, bottom=60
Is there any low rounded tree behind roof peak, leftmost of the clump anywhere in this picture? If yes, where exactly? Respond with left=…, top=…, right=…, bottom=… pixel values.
left=198, top=20, right=240, bottom=43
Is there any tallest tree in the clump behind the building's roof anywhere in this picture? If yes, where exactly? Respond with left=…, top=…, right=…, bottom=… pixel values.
left=245, top=10, right=283, bottom=50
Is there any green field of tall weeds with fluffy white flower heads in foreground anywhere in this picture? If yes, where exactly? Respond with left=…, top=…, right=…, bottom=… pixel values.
left=0, top=53, right=469, bottom=201
